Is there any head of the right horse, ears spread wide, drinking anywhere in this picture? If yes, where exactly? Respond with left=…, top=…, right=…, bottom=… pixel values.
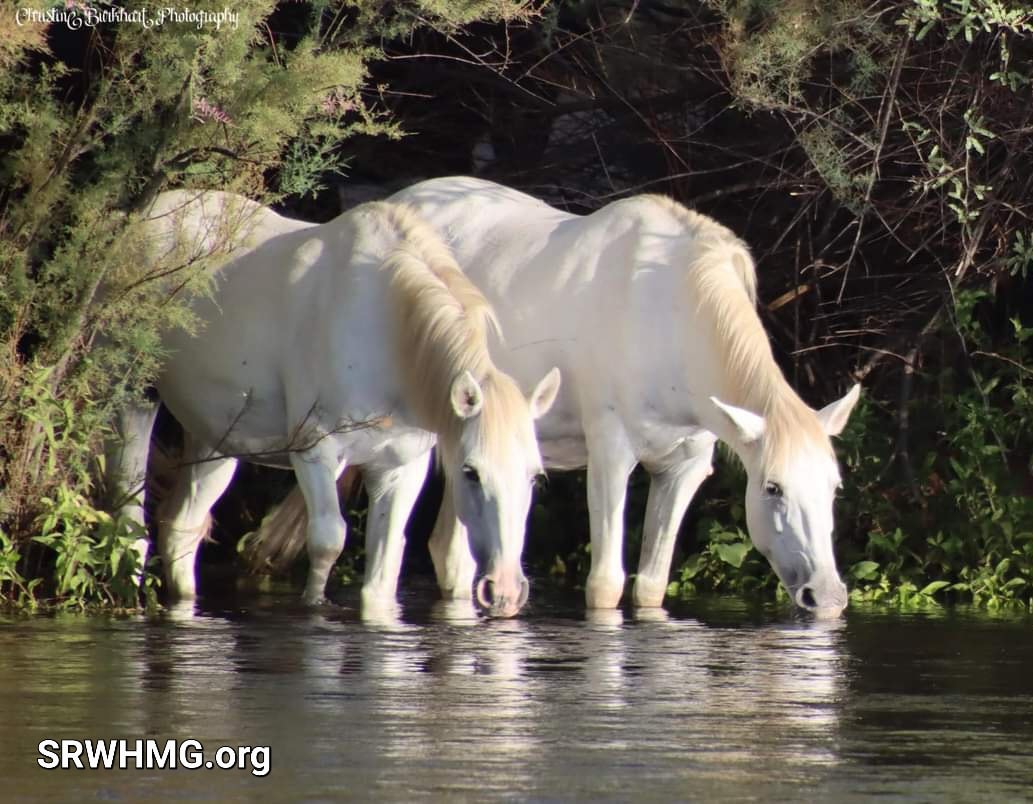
left=713, top=385, right=860, bottom=617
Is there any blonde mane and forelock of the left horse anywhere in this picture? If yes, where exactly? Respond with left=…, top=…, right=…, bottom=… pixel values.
left=369, top=202, right=529, bottom=460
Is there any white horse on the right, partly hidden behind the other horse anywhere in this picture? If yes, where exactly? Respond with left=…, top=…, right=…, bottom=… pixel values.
left=388, top=178, right=859, bottom=616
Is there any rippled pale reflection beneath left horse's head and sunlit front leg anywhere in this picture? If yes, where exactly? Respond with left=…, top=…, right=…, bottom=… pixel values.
left=339, top=600, right=543, bottom=798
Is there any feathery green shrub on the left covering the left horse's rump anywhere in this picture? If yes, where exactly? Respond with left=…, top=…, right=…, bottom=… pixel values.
left=0, top=0, right=522, bottom=605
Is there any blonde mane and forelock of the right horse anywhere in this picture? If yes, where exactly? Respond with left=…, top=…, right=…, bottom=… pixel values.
left=652, top=195, right=833, bottom=474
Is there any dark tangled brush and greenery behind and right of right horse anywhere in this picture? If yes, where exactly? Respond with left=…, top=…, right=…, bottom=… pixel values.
left=356, top=0, right=1033, bottom=606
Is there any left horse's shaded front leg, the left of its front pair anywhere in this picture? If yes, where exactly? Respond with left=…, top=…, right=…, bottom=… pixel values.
left=290, top=438, right=348, bottom=606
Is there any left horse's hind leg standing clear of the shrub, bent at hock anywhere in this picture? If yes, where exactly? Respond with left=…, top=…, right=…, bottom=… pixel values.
left=158, top=434, right=237, bottom=599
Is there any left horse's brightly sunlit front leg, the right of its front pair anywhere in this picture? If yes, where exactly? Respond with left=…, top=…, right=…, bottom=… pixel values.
left=363, top=450, right=431, bottom=608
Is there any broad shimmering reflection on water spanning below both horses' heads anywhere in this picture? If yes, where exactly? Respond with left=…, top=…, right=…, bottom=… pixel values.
left=330, top=600, right=847, bottom=798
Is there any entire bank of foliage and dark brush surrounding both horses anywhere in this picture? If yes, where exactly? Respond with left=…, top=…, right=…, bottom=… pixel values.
left=0, top=0, right=1033, bottom=607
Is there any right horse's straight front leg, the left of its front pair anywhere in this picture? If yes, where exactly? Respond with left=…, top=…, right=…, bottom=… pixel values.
left=585, top=423, right=636, bottom=609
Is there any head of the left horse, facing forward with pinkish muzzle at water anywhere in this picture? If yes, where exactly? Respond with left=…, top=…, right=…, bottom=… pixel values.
left=441, top=368, right=560, bottom=617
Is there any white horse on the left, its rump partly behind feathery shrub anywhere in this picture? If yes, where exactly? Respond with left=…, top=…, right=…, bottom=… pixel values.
left=105, top=191, right=559, bottom=616
